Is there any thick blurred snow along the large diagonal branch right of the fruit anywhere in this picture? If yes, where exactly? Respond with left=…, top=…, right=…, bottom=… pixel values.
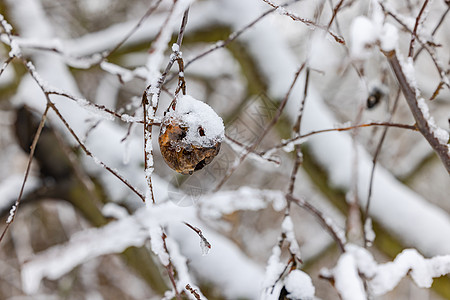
left=222, top=0, right=450, bottom=256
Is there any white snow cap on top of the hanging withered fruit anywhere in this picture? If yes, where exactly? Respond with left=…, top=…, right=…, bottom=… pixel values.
left=163, top=95, right=225, bottom=147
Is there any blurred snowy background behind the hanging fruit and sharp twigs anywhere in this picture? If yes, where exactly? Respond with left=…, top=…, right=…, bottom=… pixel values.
left=0, top=0, right=450, bottom=300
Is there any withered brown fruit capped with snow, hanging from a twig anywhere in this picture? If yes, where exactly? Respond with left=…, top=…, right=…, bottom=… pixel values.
left=159, top=95, right=224, bottom=175
